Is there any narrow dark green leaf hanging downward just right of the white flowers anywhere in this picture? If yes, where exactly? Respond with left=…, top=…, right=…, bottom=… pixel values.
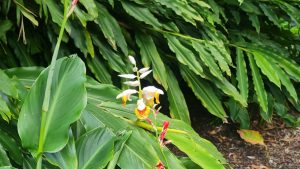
left=166, top=69, right=191, bottom=124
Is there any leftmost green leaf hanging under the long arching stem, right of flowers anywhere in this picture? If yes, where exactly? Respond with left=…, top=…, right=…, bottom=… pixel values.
left=164, top=34, right=204, bottom=77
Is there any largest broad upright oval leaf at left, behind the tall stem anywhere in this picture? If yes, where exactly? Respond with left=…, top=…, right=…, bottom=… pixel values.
left=18, top=56, right=87, bottom=153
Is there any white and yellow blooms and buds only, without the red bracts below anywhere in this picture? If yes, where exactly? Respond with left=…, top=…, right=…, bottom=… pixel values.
left=117, top=56, right=164, bottom=120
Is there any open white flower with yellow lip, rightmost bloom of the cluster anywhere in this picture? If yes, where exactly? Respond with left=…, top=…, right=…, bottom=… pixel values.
left=143, top=86, right=164, bottom=106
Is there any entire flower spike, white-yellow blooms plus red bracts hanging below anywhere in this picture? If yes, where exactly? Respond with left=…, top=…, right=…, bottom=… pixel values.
left=117, top=56, right=170, bottom=169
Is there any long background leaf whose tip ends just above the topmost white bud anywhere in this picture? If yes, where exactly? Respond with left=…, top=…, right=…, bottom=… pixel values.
left=95, top=3, right=128, bottom=56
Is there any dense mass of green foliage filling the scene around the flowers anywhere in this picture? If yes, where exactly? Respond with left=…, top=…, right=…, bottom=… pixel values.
left=0, top=0, right=300, bottom=169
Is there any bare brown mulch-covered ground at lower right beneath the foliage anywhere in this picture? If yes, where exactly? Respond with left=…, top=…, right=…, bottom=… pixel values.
left=193, top=119, right=300, bottom=169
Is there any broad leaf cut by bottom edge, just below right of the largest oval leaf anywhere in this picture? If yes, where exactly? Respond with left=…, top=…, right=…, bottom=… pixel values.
left=76, top=128, right=115, bottom=169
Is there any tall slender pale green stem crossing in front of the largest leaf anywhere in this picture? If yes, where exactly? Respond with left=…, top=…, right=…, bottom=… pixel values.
left=36, top=0, right=68, bottom=169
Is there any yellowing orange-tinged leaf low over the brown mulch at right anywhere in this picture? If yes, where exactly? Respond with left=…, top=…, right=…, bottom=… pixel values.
left=237, top=130, right=265, bottom=145
